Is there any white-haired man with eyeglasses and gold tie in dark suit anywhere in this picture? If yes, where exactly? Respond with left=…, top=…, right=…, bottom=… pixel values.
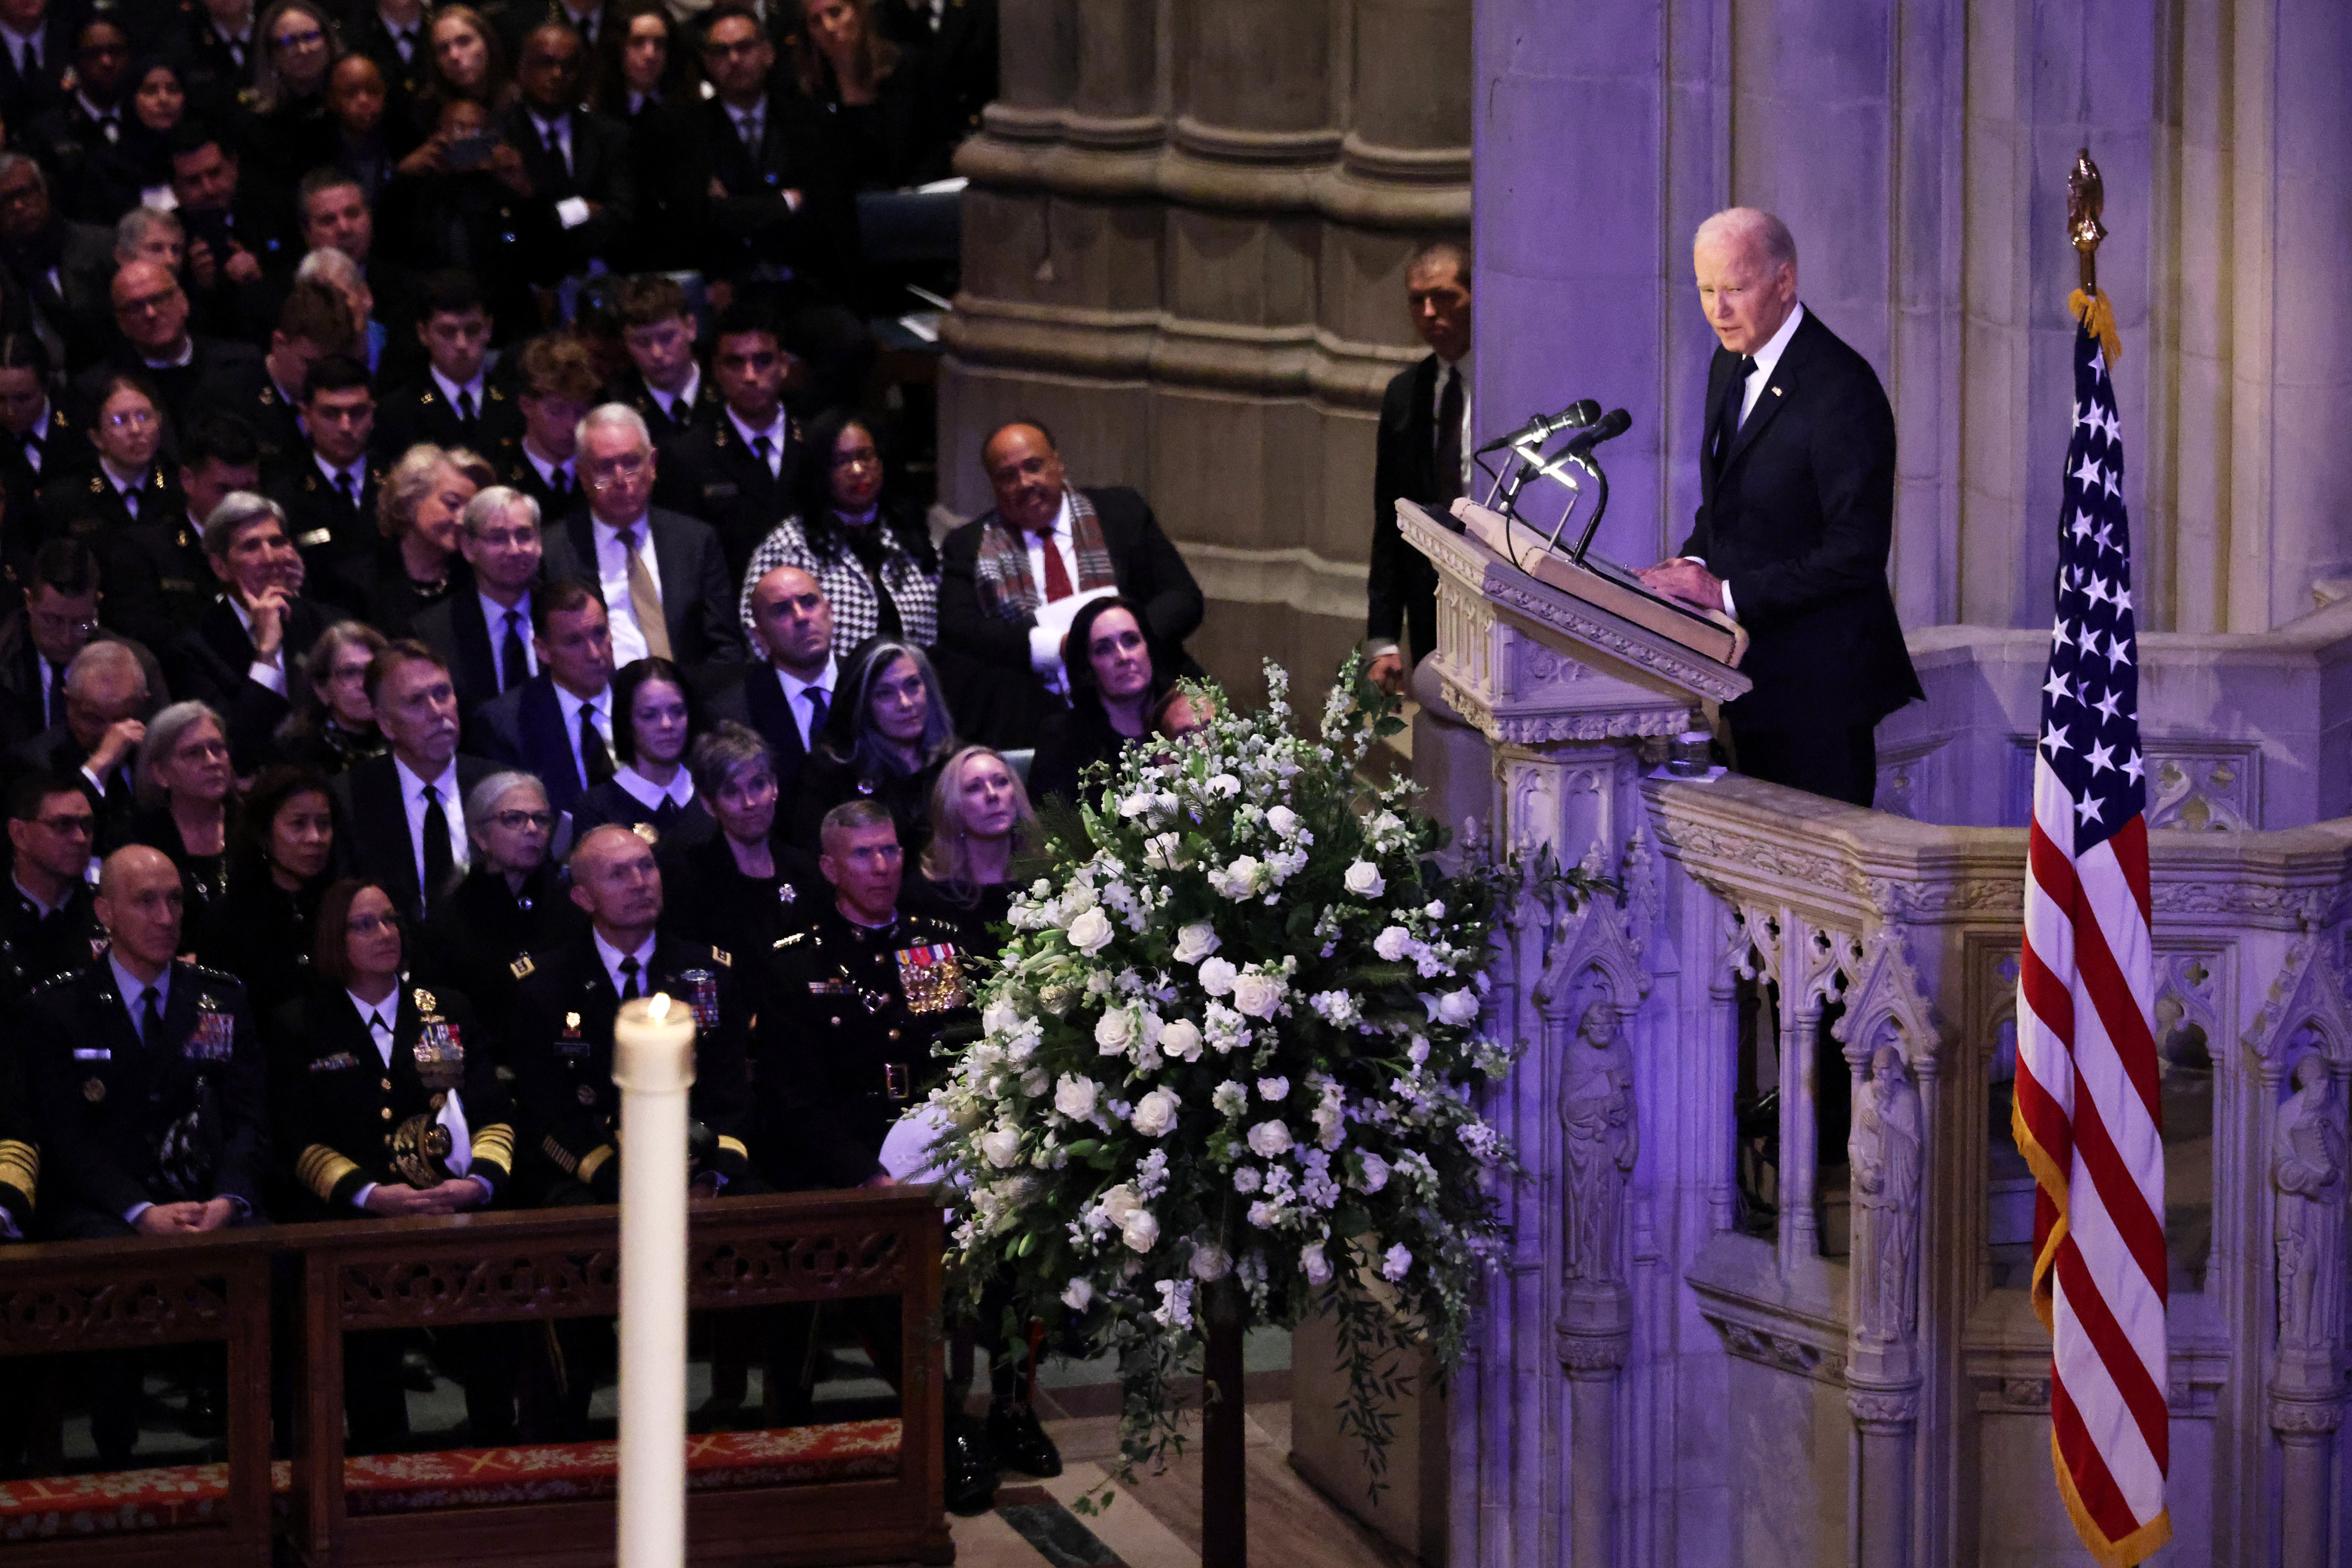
left=548, top=402, right=745, bottom=670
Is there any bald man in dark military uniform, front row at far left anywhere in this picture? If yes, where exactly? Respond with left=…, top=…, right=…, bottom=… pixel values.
left=16, top=844, right=268, bottom=1469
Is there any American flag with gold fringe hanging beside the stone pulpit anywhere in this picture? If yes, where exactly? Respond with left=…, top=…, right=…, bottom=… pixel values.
left=2011, top=313, right=2171, bottom=1568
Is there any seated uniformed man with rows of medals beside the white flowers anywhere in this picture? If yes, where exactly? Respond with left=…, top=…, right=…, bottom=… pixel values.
left=753, top=799, right=1061, bottom=1514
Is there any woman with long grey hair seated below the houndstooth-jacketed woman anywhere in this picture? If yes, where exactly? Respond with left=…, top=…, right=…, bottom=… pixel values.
left=790, top=637, right=955, bottom=858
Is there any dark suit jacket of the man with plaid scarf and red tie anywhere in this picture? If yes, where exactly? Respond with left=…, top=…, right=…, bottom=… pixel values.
left=939, top=485, right=1204, bottom=750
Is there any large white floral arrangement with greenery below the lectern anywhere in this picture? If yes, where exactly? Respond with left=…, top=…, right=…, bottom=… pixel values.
left=934, top=663, right=1576, bottom=1476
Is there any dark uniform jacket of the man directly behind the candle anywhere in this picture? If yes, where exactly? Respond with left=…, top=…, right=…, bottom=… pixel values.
left=506, top=931, right=753, bottom=1204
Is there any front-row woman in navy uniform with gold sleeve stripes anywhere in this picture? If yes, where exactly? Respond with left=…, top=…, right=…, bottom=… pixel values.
left=271, top=879, right=517, bottom=1453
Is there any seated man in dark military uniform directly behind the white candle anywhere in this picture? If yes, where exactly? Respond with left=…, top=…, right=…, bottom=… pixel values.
left=508, top=823, right=764, bottom=1206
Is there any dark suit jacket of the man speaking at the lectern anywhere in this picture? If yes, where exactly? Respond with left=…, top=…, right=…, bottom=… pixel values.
left=1679, top=310, right=1924, bottom=733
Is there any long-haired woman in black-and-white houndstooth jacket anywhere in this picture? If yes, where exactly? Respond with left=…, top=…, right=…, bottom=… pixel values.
left=739, top=409, right=939, bottom=661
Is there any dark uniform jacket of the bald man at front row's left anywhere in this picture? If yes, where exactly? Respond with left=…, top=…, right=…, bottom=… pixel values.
left=24, top=959, right=271, bottom=1234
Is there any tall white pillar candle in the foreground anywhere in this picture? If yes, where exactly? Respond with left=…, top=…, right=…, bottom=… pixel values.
left=612, top=997, right=694, bottom=1568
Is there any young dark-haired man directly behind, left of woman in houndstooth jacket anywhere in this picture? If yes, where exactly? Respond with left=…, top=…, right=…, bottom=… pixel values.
left=656, top=301, right=799, bottom=583
